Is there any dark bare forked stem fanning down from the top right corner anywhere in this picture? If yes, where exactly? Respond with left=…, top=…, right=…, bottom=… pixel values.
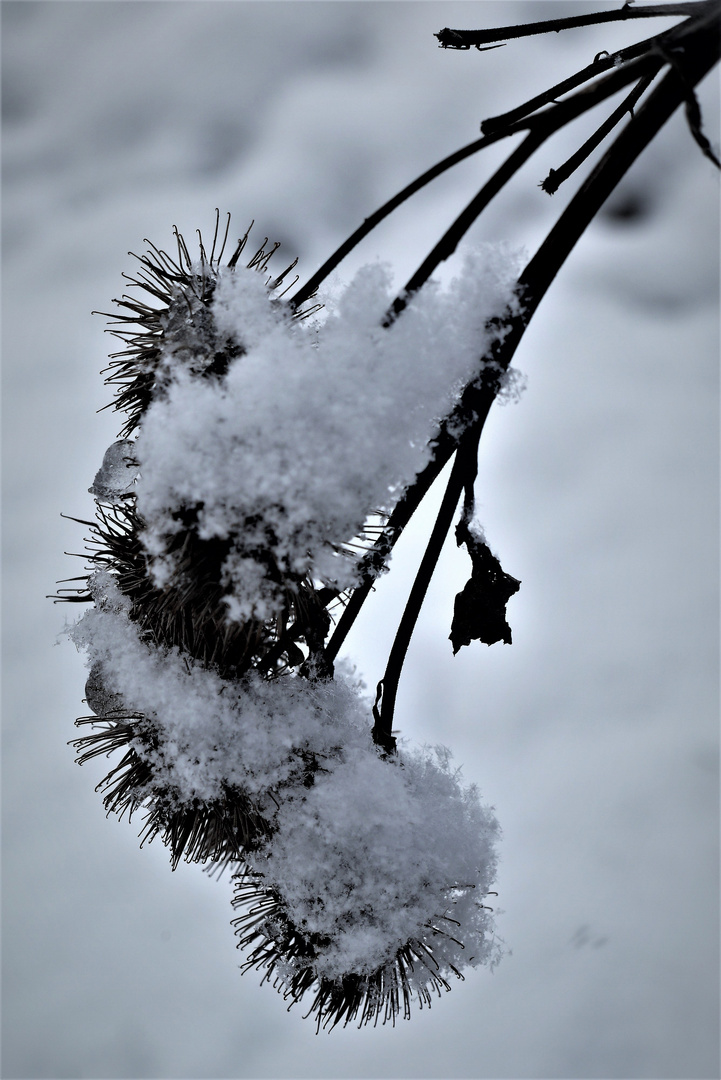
left=326, top=2, right=720, bottom=750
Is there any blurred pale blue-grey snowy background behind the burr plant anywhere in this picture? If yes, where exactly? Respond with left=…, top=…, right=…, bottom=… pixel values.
left=2, top=0, right=719, bottom=1078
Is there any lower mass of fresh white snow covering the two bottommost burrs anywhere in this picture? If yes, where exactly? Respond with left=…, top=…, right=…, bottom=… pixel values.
left=70, top=571, right=501, bottom=987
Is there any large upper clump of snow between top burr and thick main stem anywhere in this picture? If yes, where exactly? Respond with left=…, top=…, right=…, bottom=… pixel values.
left=136, top=245, right=516, bottom=619
